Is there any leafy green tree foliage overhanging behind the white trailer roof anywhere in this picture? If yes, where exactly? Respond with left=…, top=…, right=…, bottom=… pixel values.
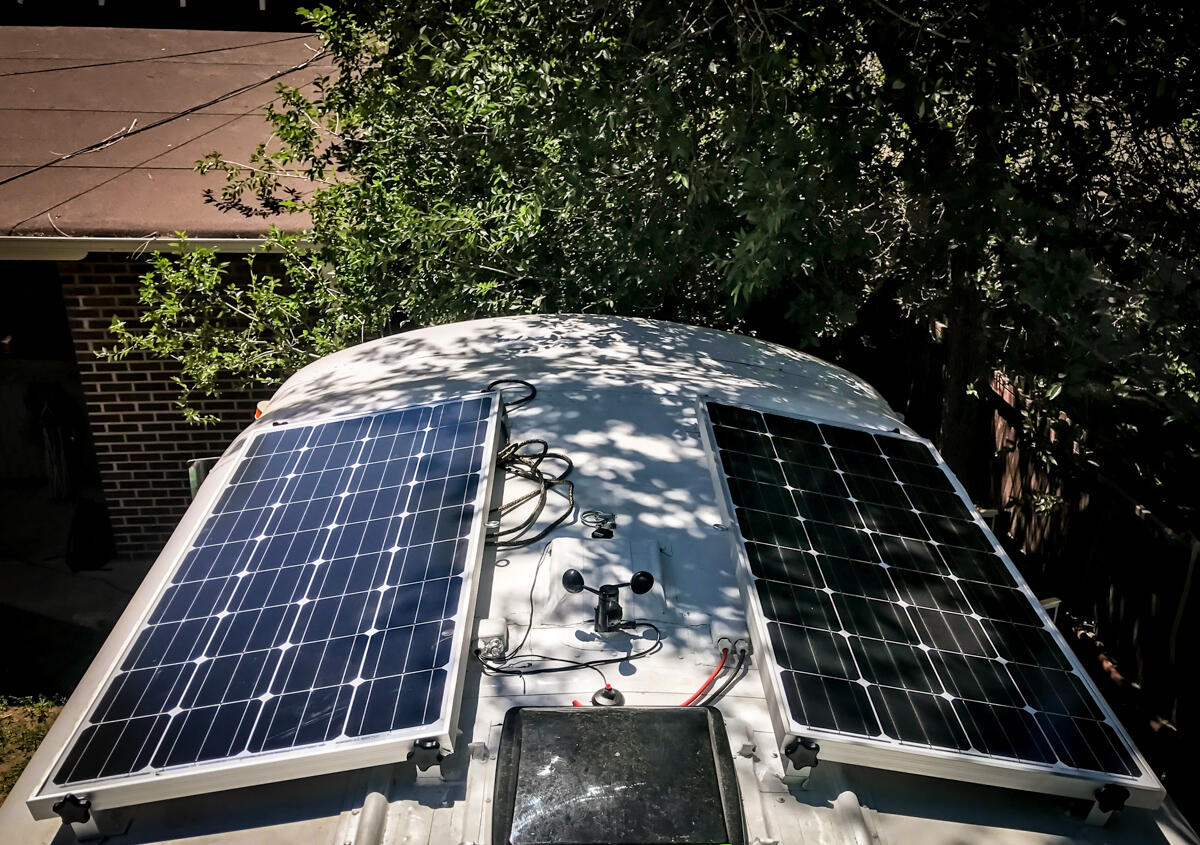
left=114, top=0, right=1200, bottom=520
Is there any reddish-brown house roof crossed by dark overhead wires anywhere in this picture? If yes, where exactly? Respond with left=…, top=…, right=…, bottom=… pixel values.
left=0, top=26, right=330, bottom=239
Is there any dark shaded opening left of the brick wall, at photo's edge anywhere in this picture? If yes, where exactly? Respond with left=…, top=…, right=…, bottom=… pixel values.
left=0, top=262, right=113, bottom=695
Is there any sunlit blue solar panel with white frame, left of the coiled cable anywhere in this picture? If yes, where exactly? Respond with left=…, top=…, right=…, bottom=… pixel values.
left=28, top=392, right=502, bottom=819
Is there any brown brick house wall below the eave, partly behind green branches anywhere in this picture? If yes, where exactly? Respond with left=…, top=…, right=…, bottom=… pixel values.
left=59, top=254, right=265, bottom=556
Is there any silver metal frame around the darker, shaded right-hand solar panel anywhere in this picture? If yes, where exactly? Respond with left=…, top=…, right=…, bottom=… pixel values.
left=696, top=396, right=1166, bottom=809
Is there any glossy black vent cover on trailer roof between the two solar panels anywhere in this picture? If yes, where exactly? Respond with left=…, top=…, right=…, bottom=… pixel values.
left=492, top=707, right=745, bottom=845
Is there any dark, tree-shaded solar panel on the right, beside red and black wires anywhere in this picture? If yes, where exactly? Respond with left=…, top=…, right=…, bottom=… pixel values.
left=704, top=402, right=1163, bottom=805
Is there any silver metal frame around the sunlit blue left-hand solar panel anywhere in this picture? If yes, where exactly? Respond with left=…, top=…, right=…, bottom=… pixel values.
left=25, top=391, right=504, bottom=820
